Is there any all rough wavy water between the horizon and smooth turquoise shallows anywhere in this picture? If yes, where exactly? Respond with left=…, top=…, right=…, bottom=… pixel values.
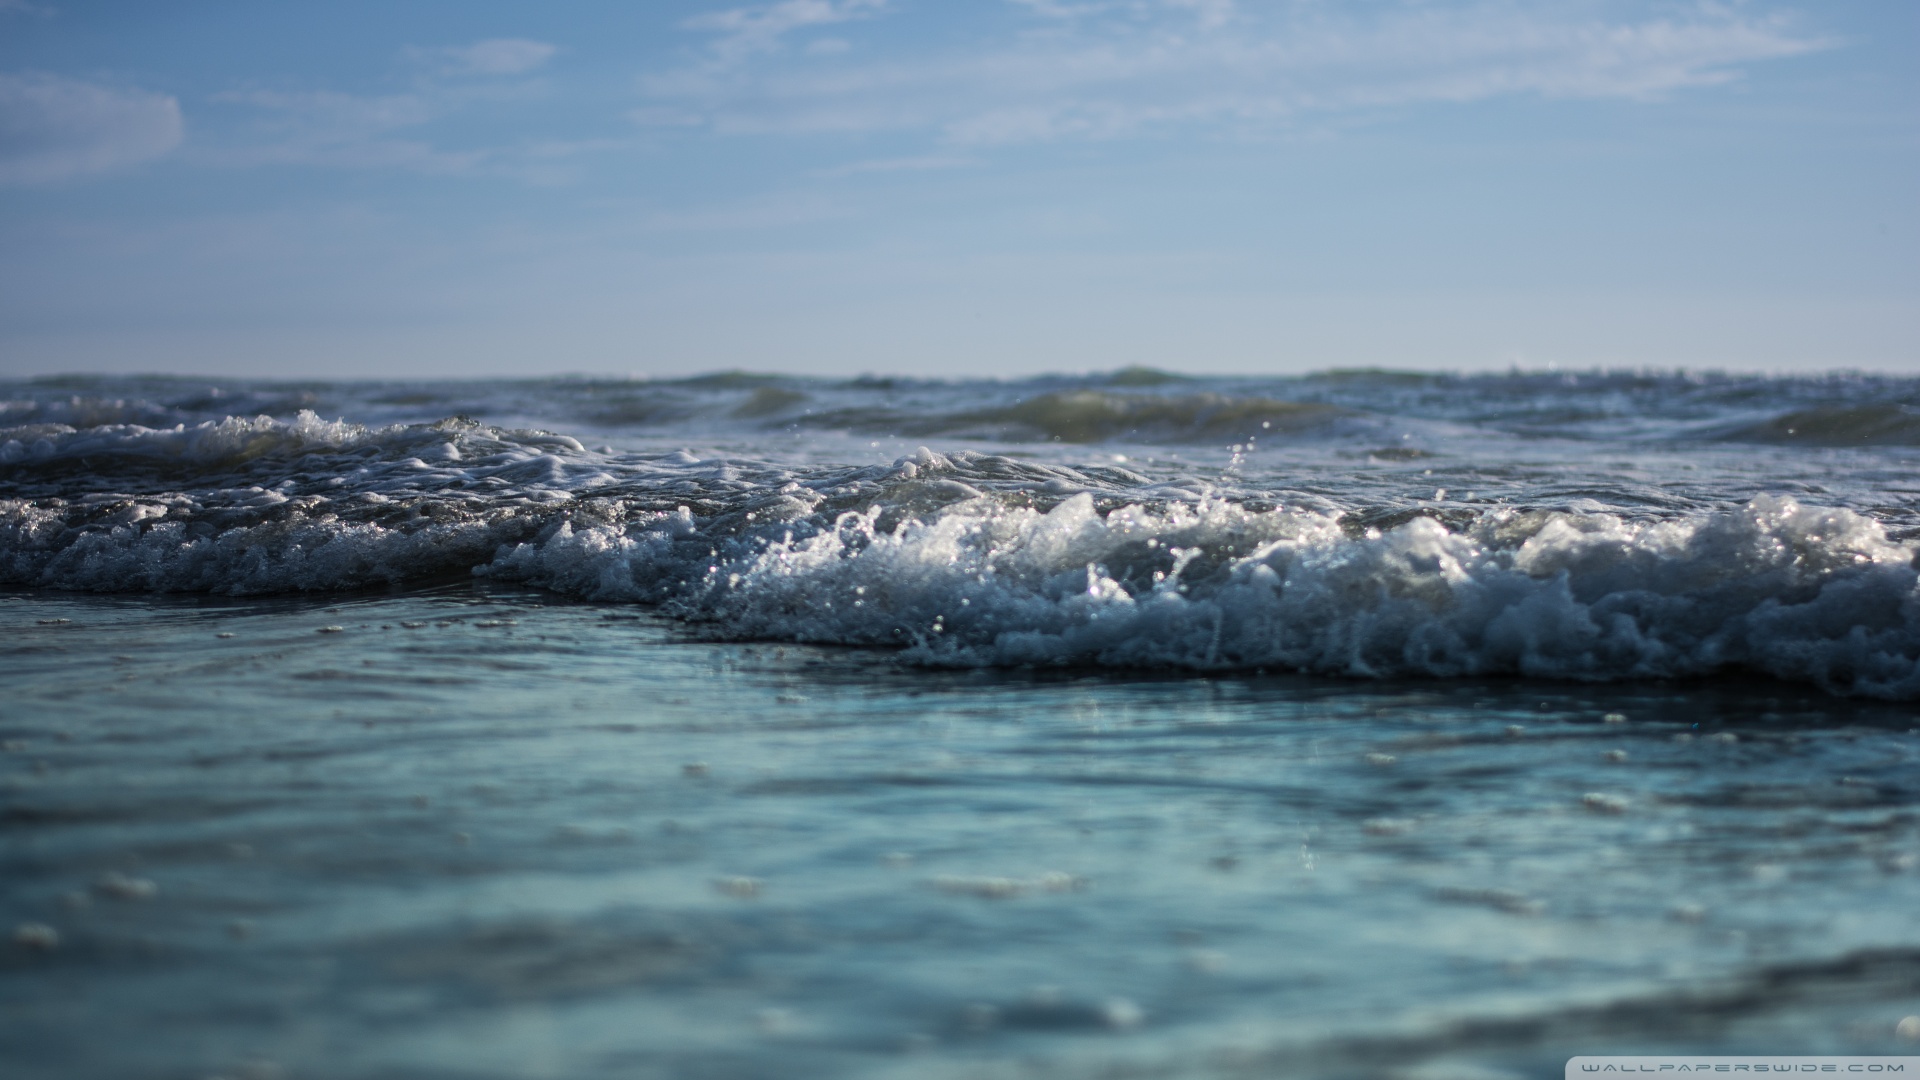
left=0, top=369, right=1920, bottom=700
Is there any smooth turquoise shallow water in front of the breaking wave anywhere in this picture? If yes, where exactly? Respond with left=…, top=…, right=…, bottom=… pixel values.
left=0, top=582, right=1920, bottom=1078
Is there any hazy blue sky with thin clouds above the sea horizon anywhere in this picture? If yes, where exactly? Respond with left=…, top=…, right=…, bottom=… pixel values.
left=0, top=0, right=1920, bottom=379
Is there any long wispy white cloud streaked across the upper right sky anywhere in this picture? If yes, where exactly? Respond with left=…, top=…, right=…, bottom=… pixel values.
left=636, top=0, right=1830, bottom=144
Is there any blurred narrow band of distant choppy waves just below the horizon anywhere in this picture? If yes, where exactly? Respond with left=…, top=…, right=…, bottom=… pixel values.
left=0, top=367, right=1920, bottom=448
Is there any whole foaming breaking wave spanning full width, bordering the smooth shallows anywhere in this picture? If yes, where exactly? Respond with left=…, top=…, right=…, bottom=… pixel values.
left=0, top=405, right=1920, bottom=700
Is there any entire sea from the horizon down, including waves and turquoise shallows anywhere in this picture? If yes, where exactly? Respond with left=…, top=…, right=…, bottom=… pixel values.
left=0, top=369, right=1920, bottom=1078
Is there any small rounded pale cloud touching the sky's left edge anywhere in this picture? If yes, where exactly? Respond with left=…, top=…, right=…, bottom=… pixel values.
left=0, top=73, right=184, bottom=184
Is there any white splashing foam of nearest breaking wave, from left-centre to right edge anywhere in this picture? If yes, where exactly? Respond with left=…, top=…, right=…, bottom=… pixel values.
left=484, top=447, right=1920, bottom=698
